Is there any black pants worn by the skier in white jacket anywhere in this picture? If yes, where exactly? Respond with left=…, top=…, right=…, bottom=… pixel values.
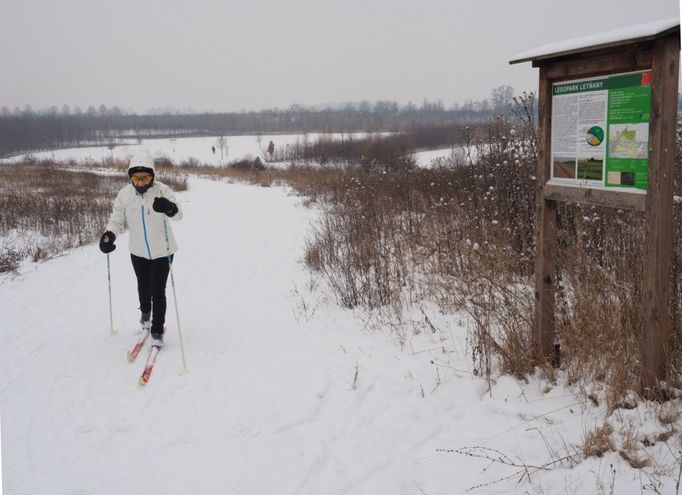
left=130, top=254, right=173, bottom=335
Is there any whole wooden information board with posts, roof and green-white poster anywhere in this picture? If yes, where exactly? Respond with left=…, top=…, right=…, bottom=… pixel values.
left=510, top=19, right=680, bottom=392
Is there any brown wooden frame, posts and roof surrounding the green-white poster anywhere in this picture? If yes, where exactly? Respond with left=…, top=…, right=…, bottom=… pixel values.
left=511, top=26, right=680, bottom=392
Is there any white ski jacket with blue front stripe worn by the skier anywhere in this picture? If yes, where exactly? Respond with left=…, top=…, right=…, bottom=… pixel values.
left=107, top=180, right=182, bottom=260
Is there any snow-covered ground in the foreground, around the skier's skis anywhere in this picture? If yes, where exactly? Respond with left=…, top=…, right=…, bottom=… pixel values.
left=0, top=179, right=679, bottom=495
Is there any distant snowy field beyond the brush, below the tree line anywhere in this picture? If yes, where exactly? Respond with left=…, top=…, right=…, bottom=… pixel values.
left=0, top=133, right=466, bottom=167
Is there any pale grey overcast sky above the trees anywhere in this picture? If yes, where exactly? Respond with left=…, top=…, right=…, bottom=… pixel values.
left=0, top=0, right=680, bottom=112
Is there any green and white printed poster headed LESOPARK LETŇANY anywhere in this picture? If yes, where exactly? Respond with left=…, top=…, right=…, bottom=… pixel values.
left=550, top=71, right=651, bottom=192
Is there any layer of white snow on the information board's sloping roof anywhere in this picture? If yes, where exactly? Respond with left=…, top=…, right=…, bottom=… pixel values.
left=509, top=17, right=680, bottom=64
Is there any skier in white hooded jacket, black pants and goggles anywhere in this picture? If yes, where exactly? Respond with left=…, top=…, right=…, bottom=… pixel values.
left=99, top=156, right=182, bottom=349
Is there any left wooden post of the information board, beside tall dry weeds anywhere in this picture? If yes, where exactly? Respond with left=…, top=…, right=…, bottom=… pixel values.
left=533, top=67, right=557, bottom=363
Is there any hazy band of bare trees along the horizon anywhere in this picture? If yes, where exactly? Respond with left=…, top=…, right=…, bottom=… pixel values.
left=0, top=86, right=514, bottom=156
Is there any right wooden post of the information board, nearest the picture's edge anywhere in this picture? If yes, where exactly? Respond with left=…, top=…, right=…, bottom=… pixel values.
left=640, top=34, right=680, bottom=394
